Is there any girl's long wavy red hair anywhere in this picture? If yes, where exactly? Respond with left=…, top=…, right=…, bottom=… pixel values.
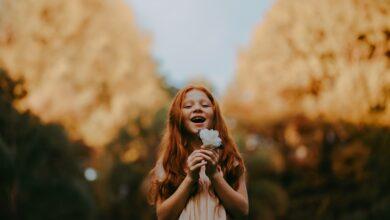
left=148, top=86, right=245, bottom=204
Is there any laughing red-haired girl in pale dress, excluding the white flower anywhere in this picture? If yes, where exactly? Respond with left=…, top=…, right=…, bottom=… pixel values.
left=149, top=86, right=248, bottom=220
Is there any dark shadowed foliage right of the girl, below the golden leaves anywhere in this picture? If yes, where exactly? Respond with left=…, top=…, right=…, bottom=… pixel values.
left=244, top=118, right=390, bottom=219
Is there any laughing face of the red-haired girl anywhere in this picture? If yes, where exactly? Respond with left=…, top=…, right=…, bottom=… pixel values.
left=181, top=89, right=214, bottom=134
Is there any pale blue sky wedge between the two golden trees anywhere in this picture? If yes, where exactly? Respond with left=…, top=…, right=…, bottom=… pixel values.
left=126, top=0, right=273, bottom=95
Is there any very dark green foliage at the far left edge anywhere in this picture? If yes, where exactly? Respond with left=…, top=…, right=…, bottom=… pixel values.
left=0, top=70, right=94, bottom=219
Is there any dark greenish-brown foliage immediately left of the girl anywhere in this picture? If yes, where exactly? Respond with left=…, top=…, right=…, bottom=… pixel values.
left=94, top=96, right=172, bottom=219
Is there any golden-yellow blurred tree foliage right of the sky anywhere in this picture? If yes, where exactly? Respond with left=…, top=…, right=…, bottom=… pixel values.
left=224, top=0, right=390, bottom=126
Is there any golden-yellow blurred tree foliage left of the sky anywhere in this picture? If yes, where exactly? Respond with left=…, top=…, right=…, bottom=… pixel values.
left=0, top=0, right=167, bottom=146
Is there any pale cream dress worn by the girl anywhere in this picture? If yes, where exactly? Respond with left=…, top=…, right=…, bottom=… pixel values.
left=156, top=163, right=228, bottom=220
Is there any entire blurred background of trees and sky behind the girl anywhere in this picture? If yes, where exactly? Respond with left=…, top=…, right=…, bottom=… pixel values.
left=0, top=0, right=390, bottom=220
